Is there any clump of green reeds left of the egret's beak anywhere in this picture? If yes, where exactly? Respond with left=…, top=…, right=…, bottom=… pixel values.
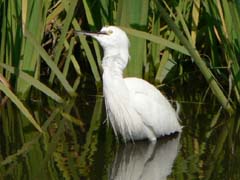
left=0, top=0, right=80, bottom=131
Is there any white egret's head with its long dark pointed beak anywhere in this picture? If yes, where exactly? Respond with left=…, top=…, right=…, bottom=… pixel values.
left=80, top=26, right=129, bottom=50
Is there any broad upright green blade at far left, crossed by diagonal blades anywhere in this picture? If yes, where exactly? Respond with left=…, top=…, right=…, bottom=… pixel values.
left=14, top=0, right=50, bottom=98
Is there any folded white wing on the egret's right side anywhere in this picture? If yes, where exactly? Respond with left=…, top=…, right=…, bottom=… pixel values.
left=124, top=78, right=181, bottom=136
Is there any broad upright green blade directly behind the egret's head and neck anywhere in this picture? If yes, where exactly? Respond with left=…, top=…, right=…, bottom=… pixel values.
left=117, top=0, right=149, bottom=77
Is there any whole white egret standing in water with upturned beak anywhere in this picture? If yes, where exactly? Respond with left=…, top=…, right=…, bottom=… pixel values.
left=79, top=26, right=181, bottom=141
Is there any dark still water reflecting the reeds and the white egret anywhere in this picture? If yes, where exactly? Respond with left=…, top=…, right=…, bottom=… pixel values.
left=0, top=88, right=240, bottom=180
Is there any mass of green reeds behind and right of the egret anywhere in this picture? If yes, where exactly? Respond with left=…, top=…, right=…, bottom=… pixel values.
left=79, top=0, right=240, bottom=113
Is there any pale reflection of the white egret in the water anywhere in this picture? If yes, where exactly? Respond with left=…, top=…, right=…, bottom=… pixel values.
left=109, top=134, right=180, bottom=180
